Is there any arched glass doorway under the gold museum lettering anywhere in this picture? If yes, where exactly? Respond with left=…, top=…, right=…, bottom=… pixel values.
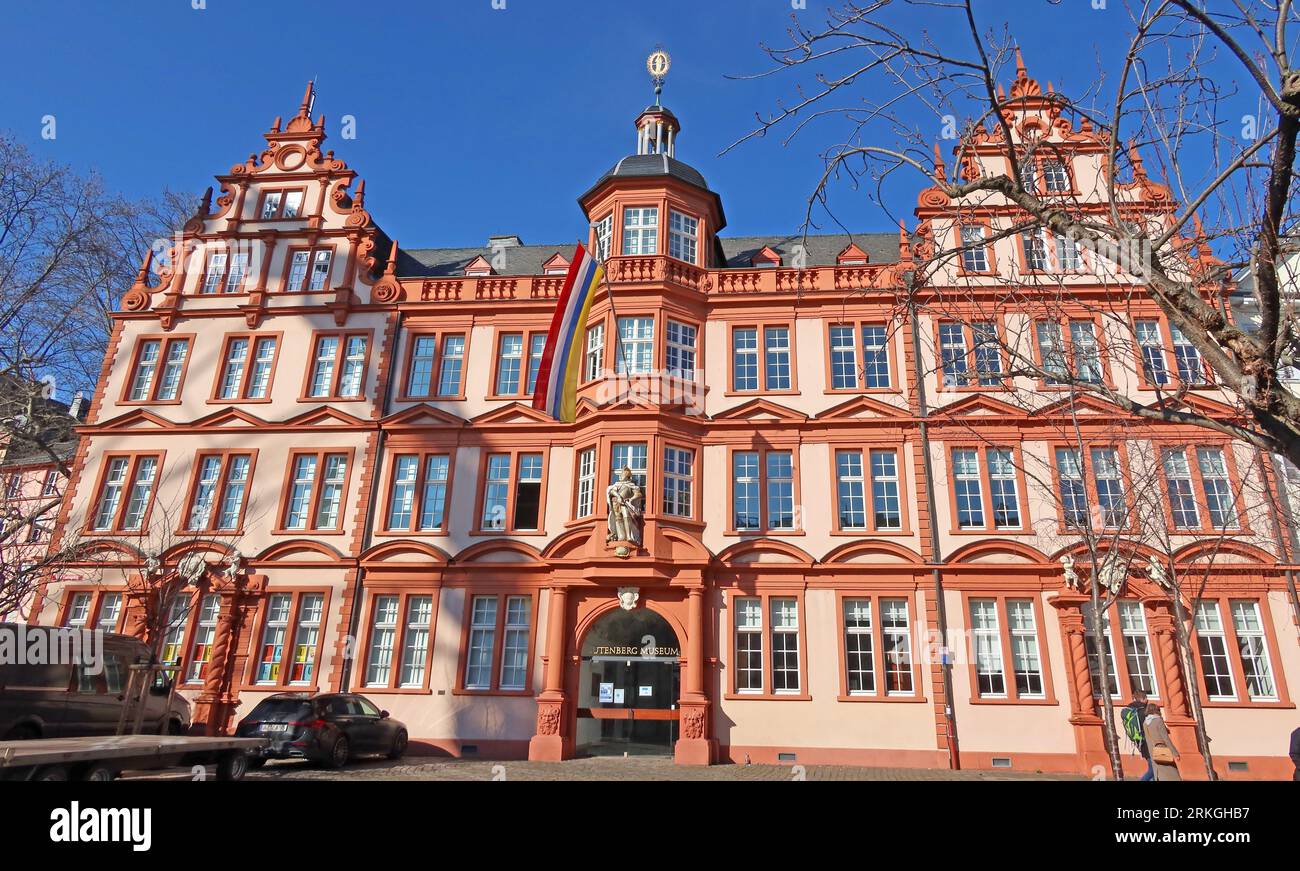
left=576, top=608, right=681, bottom=757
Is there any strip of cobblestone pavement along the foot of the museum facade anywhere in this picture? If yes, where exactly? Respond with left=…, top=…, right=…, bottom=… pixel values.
left=197, top=757, right=1083, bottom=781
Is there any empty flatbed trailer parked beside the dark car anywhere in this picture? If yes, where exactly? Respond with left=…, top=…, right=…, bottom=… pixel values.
left=0, top=735, right=267, bottom=781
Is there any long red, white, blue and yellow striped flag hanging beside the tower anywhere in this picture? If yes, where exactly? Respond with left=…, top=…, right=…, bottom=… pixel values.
left=533, top=244, right=605, bottom=424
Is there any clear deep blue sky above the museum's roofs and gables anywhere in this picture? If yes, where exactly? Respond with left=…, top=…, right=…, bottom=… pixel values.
left=0, top=0, right=1247, bottom=248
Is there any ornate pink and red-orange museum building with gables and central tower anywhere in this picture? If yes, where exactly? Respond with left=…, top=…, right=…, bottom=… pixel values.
left=34, top=66, right=1300, bottom=777
